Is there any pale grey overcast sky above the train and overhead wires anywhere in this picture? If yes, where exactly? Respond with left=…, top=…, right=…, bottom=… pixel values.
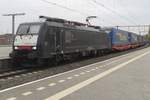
left=0, top=0, right=150, bottom=34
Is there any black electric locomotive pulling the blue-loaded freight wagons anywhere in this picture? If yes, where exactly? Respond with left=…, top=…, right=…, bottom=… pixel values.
left=10, top=16, right=111, bottom=64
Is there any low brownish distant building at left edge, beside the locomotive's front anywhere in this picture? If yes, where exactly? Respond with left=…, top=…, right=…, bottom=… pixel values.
left=0, top=34, right=13, bottom=45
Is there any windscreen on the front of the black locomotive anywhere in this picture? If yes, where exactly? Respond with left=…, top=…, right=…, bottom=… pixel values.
left=17, top=24, right=41, bottom=34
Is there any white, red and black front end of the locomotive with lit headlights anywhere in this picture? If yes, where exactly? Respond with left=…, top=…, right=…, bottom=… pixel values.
left=10, top=23, right=42, bottom=60
